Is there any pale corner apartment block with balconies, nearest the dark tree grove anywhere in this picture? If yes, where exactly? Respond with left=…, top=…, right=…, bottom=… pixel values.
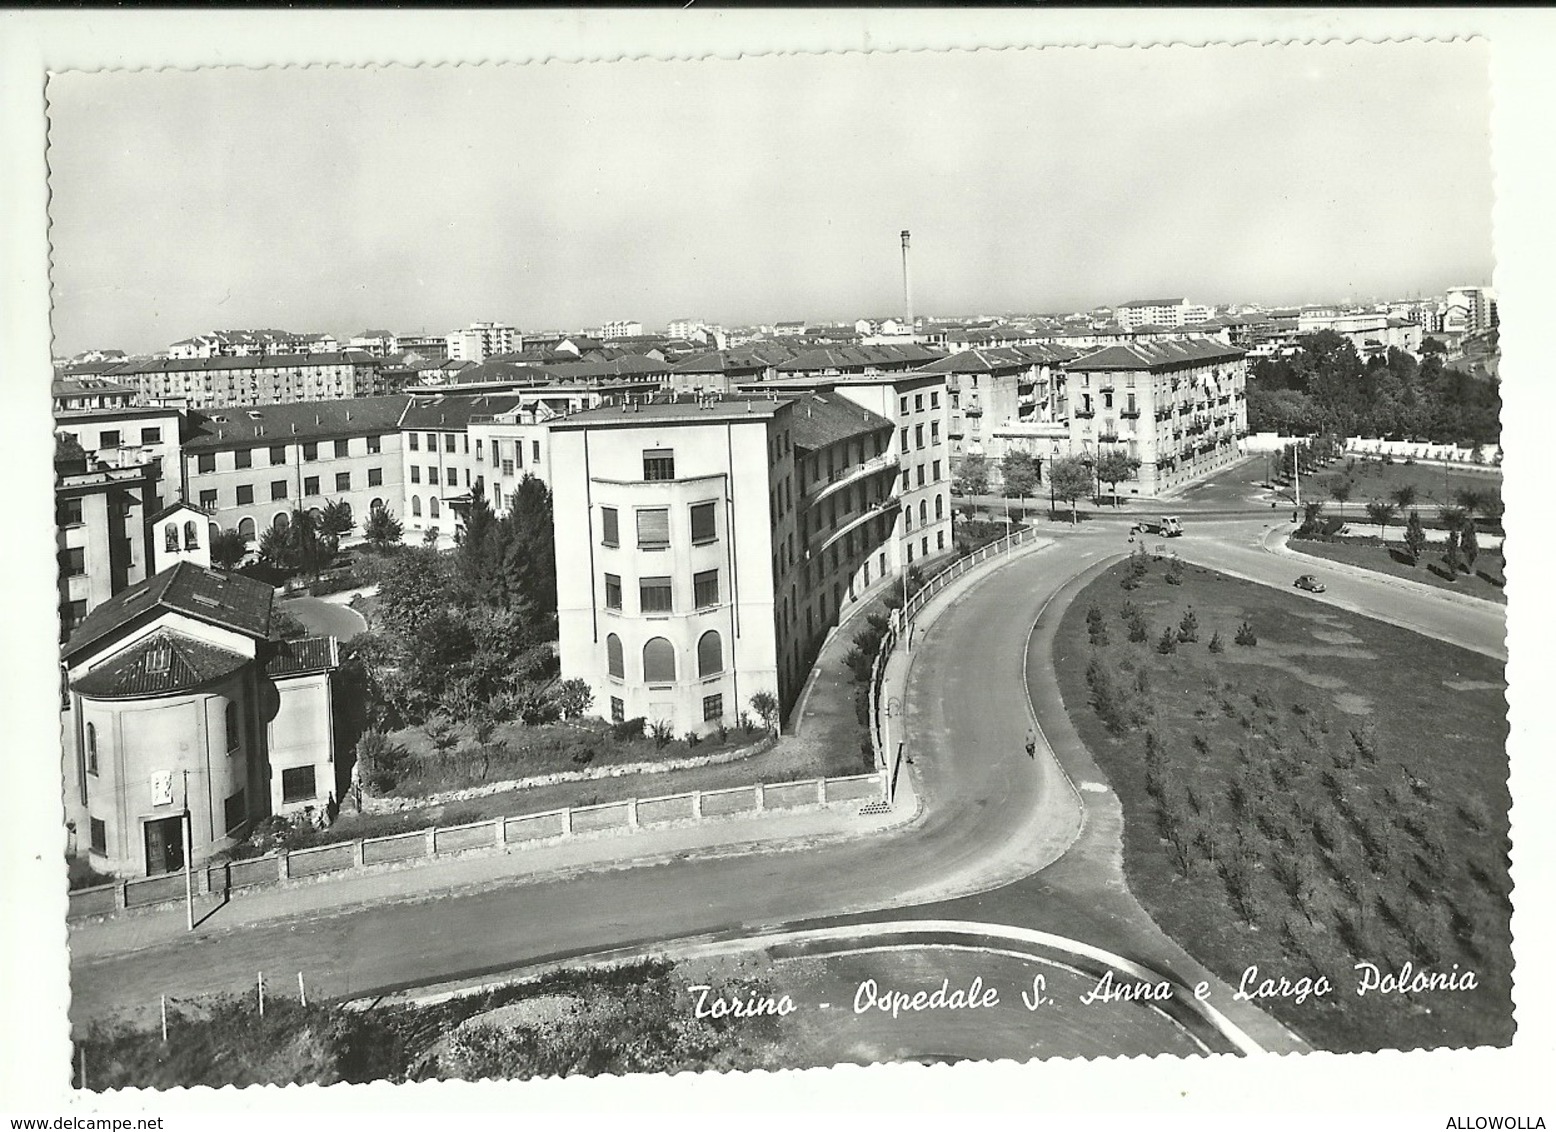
left=1064, top=339, right=1248, bottom=496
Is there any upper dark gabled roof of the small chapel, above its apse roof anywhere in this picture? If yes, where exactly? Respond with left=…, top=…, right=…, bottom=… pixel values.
left=62, top=561, right=275, bottom=659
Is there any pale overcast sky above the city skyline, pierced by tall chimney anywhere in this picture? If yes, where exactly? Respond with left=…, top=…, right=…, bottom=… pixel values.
left=48, top=42, right=1492, bottom=355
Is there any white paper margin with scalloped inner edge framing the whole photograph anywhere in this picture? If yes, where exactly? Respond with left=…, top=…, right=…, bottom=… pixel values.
left=0, top=9, right=1556, bottom=1127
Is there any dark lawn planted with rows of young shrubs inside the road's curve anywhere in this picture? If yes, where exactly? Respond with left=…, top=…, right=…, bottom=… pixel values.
left=1053, top=561, right=1512, bottom=1051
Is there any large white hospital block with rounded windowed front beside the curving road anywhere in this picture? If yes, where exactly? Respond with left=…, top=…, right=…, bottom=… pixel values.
left=551, top=393, right=898, bottom=734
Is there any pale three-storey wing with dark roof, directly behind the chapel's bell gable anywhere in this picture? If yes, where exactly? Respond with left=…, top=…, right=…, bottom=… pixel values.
left=180, top=393, right=409, bottom=543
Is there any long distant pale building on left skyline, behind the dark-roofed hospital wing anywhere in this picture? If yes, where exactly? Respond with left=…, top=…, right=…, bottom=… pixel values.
left=109, top=351, right=387, bottom=409
